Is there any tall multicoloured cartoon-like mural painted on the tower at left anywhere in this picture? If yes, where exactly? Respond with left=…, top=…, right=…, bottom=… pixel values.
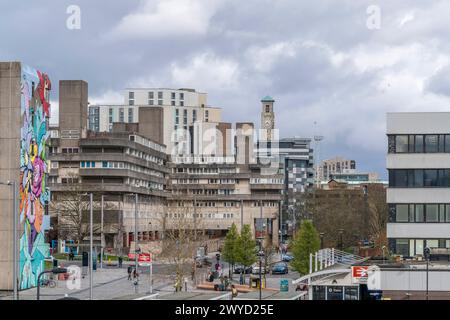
left=19, top=65, right=51, bottom=289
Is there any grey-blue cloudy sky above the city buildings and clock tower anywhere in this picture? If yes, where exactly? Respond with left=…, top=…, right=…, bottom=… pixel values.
left=0, top=0, right=450, bottom=177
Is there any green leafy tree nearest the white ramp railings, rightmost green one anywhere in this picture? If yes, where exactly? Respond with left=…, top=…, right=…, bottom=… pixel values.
left=291, top=220, right=320, bottom=274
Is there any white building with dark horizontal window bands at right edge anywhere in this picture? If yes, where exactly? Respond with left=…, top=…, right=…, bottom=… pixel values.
left=387, top=112, right=450, bottom=257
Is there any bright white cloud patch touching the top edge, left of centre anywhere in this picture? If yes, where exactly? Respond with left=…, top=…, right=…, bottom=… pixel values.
left=109, top=0, right=221, bottom=39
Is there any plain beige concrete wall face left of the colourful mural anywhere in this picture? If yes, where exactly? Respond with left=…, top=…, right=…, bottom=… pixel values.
left=0, top=62, right=21, bottom=290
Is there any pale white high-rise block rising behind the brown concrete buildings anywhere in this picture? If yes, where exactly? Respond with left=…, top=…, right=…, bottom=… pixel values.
left=89, top=88, right=221, bottom=154
